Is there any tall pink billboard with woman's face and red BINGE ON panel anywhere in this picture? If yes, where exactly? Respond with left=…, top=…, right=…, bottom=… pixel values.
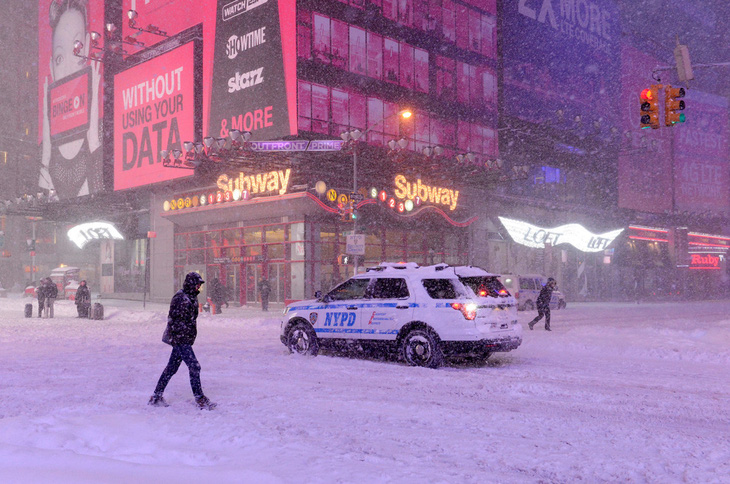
left=38, top=0, right=104, bottom=200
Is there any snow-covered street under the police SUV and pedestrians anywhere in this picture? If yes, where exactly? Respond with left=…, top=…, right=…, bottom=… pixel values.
left=0, top=298, right=730, bottom=483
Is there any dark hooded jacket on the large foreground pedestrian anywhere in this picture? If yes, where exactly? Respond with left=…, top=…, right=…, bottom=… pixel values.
left=162, top=272, right=203, bottom=346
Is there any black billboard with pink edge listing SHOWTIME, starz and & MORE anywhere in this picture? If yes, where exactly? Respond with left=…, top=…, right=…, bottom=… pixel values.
left=208, top=0, right=297, bottom=140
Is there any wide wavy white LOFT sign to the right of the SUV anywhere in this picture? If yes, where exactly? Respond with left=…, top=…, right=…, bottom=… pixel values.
left=499, top=217, right=624, bottom=252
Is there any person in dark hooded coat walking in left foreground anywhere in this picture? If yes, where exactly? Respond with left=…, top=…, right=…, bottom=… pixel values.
left=148, top=272, right=216, bottom=410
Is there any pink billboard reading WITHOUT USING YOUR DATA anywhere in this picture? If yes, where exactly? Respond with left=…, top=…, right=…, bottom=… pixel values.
left=114, top=42, right=201, bottom=190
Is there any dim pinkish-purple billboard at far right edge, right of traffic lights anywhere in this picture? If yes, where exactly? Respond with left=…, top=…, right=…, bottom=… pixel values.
left=672, top=90, right=730, bottom=212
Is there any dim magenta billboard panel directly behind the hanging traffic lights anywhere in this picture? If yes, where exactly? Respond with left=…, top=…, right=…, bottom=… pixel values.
left=618, top=45, right=673, bottom=213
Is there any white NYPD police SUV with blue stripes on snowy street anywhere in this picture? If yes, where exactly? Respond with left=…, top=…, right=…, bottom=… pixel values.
left=281, top=263, right=522, bottom=368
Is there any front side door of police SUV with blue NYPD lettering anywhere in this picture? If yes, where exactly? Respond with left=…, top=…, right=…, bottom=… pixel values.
left=318, top=278, right=370, bottom=339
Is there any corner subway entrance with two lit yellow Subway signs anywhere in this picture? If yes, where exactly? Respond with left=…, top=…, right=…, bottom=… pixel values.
left=155, top=168, right=477, bottom=305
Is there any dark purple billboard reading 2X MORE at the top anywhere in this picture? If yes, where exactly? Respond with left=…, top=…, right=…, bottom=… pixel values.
left=502, top=0, right=621, bottom=130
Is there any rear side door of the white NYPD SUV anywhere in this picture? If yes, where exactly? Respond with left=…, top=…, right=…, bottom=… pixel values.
left=362, top=277, right=413, bottom=340
